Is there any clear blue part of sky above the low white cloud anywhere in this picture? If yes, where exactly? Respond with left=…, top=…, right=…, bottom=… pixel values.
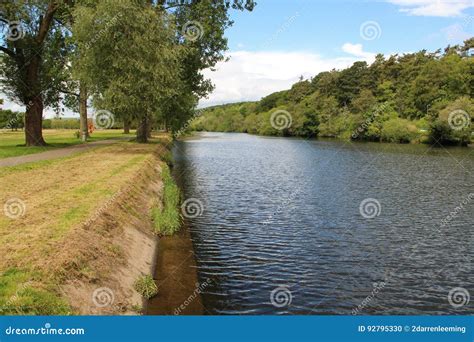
left=227, top=0, right=474, bottom=57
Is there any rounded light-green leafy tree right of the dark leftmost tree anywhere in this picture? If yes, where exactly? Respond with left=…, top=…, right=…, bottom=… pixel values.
left=73, top=0, right=181, bottom=142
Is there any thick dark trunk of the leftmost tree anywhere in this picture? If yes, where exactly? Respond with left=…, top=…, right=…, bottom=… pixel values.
left=25, top=95, right=46, bottom=146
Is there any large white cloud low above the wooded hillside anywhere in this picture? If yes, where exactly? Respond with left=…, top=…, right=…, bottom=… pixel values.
left=200, top=48, right=375, bottom=107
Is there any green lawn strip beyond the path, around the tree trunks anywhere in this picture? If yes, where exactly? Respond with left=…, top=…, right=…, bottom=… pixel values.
left=0, top=129, right=135, bottom=159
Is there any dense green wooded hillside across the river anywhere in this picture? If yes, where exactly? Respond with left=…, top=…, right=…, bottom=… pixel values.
left=192, top=38, right=474, bottom=145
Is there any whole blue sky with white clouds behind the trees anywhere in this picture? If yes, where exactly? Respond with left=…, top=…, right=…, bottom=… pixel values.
left=0, top=0, right=474, bottom=117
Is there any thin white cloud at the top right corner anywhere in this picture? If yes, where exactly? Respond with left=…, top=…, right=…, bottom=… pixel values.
left=388, top=0, right=474, bottom=17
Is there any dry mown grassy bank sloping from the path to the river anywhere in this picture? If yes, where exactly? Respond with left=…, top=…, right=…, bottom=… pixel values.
left=0, top=137, right=174, bottom=314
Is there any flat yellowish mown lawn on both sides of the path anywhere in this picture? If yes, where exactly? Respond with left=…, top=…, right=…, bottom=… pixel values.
left=0, top=138, right=163, bottom=314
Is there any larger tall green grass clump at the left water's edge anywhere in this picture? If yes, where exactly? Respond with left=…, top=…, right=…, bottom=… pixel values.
left=151, top=164, right=181, bottom=235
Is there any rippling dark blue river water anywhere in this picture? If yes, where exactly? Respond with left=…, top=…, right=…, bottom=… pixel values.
left=173, top=133, right=474, bottom=315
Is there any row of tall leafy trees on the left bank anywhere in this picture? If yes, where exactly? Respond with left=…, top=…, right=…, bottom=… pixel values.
left=0, top=0, right=255, bottom=146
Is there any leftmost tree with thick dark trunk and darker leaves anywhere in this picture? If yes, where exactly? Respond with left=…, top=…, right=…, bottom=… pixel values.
left=0, top=0, right=70, bottom=146
